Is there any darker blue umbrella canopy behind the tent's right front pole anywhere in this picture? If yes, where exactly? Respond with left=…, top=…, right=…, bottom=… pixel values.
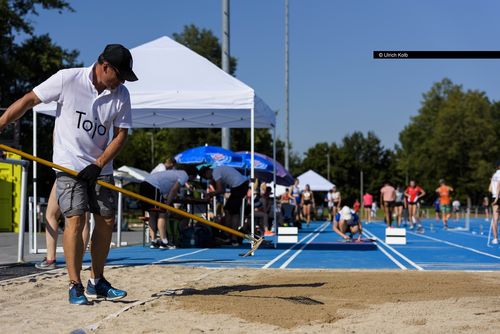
left=236, top=151, right=295, bottom=186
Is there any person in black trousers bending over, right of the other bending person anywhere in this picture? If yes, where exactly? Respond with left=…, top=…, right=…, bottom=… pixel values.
left=198, top=166, right=248, bottom=246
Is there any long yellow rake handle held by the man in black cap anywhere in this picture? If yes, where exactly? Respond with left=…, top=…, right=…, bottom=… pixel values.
left=0, top=144, right=254, bottom=242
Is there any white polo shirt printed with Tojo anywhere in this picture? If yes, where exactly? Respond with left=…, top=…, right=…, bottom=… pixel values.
left=33, top=66, right=132, bottom=175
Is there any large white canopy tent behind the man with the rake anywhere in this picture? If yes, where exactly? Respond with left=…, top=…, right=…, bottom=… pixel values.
left=33, top=36, right=275, bottom=250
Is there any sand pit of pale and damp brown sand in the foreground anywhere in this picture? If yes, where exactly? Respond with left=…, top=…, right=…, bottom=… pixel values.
left=0, top=266, right=500, bottom=333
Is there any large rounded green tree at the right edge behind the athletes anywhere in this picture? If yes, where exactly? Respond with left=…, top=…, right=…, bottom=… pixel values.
left=398, top=79, right=499, bottom=203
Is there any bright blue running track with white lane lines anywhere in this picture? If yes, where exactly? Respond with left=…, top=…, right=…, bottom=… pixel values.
left=71, top=219, right=500, bottom=271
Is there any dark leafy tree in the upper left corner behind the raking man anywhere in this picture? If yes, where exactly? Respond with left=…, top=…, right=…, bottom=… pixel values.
left=0, top=0, right=81, bottom=196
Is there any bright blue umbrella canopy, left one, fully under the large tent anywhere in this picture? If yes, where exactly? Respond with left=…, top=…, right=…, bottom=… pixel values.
left=175, top=145, right=244, bottom=168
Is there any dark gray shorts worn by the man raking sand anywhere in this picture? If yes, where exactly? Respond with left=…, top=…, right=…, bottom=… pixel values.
left=56, top=173, right=118, bottom=217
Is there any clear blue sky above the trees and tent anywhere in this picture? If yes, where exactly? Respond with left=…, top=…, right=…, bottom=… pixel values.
left=24, top=0, right=500, bottom=154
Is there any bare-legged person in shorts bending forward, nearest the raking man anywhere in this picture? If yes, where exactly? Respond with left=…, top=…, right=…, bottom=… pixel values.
left=139, top=166, right=198, bottom=249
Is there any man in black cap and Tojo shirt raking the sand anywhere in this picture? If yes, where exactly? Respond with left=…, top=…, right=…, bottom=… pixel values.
left=0, top=44, right=137, bottom=304
